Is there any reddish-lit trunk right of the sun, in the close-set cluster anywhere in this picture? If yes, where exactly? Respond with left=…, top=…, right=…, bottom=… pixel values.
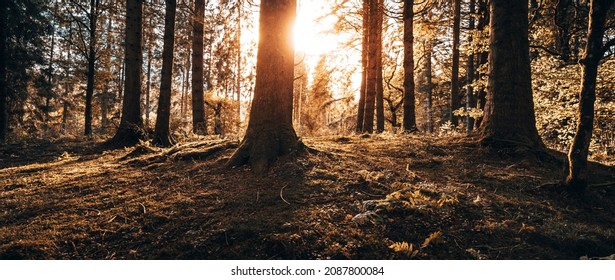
left=363, top=0, right=379, bottom=133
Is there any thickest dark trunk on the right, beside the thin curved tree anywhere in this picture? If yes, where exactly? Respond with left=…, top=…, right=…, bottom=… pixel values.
left=481, top=0, right=544, bottom=149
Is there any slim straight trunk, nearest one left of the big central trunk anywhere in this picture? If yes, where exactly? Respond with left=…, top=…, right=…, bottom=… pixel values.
left=192, top=0, right=207, bottom=135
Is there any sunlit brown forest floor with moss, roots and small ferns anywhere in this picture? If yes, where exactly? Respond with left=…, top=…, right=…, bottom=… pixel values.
left=0, top=135, right=615, bottom=259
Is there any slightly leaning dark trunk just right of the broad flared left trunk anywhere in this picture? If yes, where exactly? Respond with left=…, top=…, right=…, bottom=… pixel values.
left=154, top=0, right=177, bottom=147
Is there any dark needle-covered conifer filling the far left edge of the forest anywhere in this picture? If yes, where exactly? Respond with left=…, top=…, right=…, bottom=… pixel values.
left=0, top=0, right=51, bottom=142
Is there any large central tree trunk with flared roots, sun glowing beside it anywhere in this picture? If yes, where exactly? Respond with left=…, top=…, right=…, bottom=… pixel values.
left=227, top=0, right=300, bottom=174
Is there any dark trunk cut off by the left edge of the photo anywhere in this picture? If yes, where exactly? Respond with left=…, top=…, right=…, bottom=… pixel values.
left=0, top=0, right=9, bottom=143
